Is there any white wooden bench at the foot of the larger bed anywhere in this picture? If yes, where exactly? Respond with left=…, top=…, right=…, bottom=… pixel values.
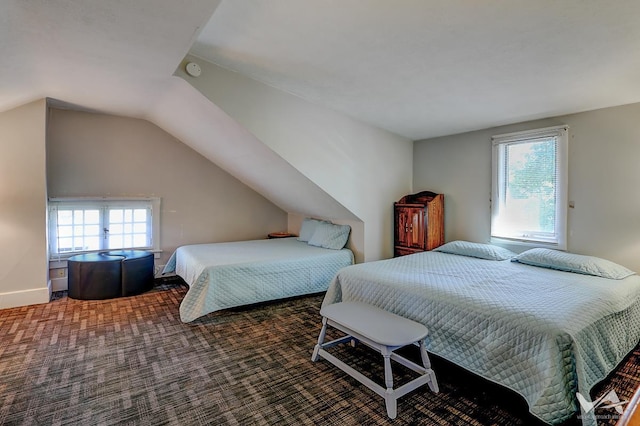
left=311, top=302, right=439, bottom=419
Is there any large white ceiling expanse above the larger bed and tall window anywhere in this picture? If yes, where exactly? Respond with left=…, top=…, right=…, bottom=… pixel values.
left=191, top=0, right=640, bottom=140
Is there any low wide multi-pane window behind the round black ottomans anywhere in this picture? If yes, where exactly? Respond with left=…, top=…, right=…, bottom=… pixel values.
left=49, top=198, right=160, bottom=257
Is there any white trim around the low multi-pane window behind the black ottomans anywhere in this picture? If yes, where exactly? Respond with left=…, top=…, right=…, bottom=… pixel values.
left=47, top=197, right=162, bottom=261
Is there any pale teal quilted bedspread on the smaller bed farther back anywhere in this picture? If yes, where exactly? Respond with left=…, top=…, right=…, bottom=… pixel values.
left=162, top=238, right=353, bottom=322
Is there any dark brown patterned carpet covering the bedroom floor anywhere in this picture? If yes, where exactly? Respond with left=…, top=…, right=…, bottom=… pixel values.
left=0, top=281, right=640, bottom=426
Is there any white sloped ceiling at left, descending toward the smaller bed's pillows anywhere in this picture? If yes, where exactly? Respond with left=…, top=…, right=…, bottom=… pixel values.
left=0, top=0, right=356, bottom=223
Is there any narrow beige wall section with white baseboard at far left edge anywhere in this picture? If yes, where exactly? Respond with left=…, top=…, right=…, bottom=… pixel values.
left=0, top=100, right=51, bottom=309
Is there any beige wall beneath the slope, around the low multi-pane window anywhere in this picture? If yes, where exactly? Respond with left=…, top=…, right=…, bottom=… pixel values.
left=47, top=109, right=287, bottom=264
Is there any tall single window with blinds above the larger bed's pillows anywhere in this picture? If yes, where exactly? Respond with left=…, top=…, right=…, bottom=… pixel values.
left=491, top=126, right=568, bottom=249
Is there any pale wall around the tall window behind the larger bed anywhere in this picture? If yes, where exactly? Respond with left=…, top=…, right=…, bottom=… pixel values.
left=413, top=104, right=640, bottom=272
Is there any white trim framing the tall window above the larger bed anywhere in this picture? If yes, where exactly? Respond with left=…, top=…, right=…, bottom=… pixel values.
left=491, top=125, right=569, bottom=250
